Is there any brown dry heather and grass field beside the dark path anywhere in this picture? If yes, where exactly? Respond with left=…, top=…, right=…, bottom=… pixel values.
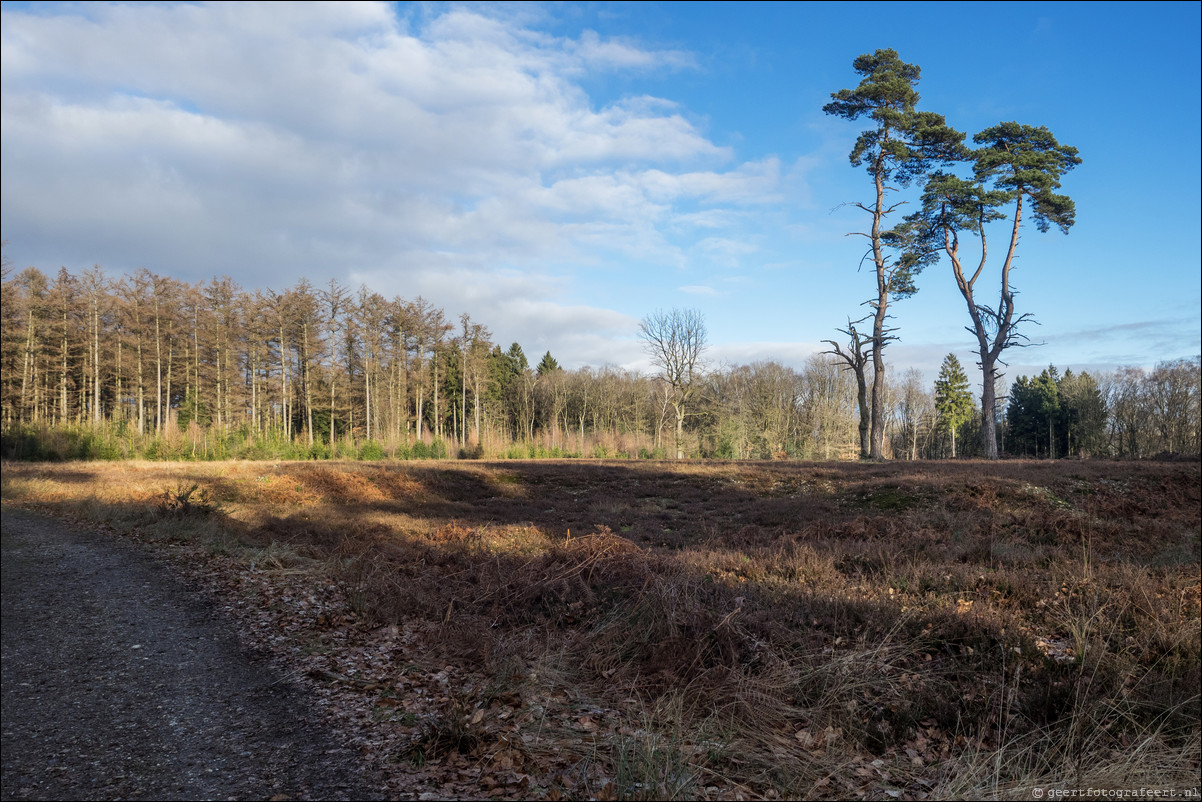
left=4, top=462, right=1202, bottom=800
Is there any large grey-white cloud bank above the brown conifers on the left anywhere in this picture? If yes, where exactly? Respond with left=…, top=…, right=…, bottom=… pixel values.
left=0, top=2, right=783, bottom=363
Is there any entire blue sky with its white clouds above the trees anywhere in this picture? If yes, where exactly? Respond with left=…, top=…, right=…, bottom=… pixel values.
left=0, top=2, right=1202, bottom=389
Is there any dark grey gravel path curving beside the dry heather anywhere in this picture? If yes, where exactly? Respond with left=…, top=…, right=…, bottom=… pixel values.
left=0, top=507, right=380, bottom=800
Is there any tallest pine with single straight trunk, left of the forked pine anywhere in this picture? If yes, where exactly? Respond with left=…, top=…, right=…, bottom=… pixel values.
left=822, top=49, right=964, bottom=459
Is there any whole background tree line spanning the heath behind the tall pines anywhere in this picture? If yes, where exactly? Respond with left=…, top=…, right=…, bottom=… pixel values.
left=0, top=266, right=1200, bottom=459
